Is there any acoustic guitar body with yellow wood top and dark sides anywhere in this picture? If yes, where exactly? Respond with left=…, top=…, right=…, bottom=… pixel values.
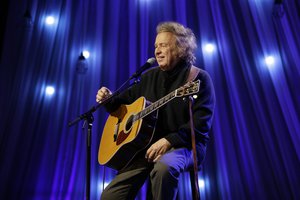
left=98, top=97, right=157, bottom=170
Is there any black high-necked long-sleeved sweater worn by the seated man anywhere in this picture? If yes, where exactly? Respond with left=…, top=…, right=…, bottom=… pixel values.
left=106, top=61, right=215, bottom=171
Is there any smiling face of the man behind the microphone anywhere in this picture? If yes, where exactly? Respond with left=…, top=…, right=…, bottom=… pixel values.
left=155, top=32, right=179, bottom=71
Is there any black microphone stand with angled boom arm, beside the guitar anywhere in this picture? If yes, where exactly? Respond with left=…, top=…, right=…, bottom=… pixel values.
left=68, top=69, right=145, bottom=200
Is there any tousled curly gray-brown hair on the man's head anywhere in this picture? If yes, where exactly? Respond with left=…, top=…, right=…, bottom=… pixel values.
left=156, top=22, right=197, bottom=65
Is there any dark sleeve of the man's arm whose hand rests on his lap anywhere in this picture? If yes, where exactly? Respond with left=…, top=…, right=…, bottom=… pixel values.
left=165, top=70, right=215, bottom=147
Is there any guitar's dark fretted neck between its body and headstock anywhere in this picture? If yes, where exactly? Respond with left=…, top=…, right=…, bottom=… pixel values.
left=134, top=90, right=177, bottom=121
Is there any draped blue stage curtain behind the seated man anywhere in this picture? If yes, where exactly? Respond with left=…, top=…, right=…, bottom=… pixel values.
left=0, top=0, right=300, bottom=199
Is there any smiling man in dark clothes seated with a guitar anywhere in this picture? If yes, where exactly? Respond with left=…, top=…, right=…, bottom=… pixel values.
left=96, top=22, right=215, bottom=200
